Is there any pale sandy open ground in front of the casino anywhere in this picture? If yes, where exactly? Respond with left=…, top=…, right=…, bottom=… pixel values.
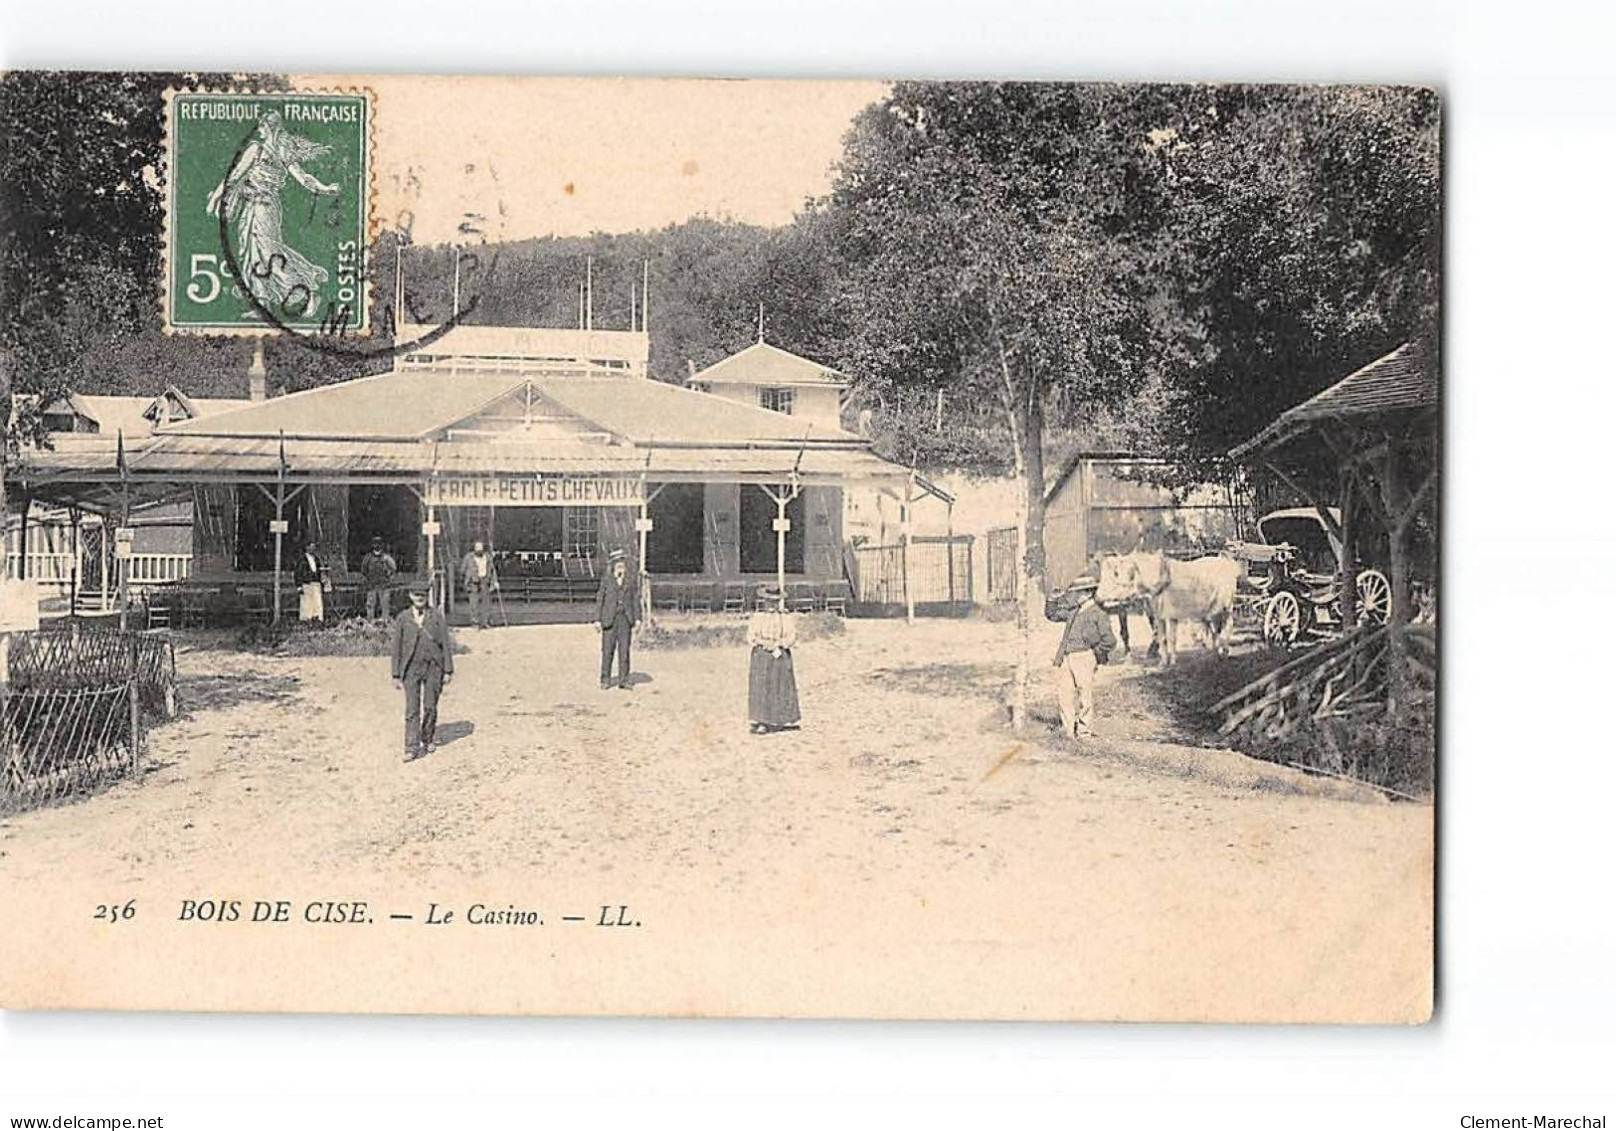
left=0, top=620, right=1432, bottom=1021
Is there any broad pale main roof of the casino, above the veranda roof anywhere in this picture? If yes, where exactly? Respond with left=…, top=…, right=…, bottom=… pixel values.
left=158, top=368, right=865, bottom=446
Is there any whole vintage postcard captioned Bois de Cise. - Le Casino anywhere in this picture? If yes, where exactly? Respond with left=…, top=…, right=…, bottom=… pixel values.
left=0, top=71, right=1441, bottom=1024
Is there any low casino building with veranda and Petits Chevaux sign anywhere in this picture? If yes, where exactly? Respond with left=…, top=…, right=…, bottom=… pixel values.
left=13, top=325, right=929, bottom=620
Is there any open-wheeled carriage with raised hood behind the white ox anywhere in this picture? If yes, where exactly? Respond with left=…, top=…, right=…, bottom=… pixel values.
left=1228, top=507, right=1391, bottom=648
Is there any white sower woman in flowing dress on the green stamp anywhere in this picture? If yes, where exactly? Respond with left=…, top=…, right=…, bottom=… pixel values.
left=207, top=110, right=339, bottom=317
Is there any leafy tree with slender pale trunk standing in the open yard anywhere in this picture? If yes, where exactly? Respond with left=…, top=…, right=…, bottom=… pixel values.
left=826, top=82, right=1170, bottom=727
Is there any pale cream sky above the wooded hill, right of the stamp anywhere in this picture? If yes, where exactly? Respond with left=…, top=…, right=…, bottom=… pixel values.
left=316, top=76, right=887, bottom=244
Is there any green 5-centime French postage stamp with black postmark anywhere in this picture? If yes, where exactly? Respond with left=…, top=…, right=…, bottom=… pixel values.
left=163, top=90, right=373, bottom=336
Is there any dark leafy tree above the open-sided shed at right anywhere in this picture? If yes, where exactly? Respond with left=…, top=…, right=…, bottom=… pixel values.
left=1139, top=86, right=1441, bottom=467
